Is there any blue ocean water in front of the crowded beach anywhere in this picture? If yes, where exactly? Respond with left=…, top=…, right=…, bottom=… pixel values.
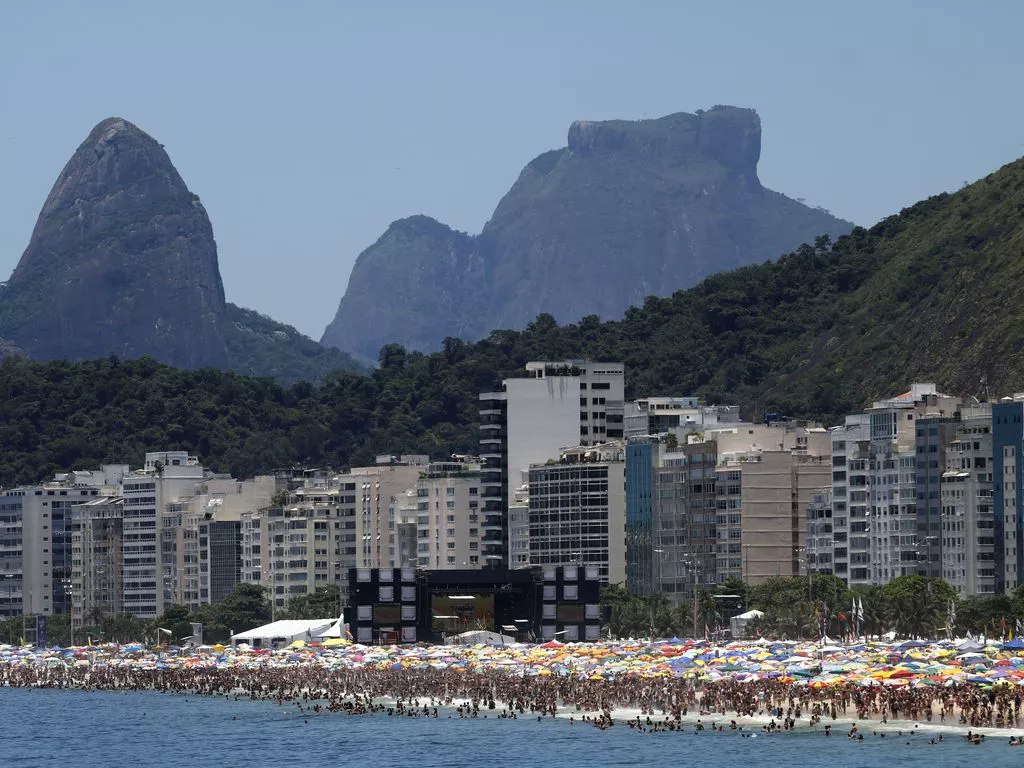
left=0, top=689, right=1024, bottom=768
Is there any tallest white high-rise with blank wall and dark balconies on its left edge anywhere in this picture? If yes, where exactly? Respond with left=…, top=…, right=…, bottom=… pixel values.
left=479, top=360, right=625, bottom=568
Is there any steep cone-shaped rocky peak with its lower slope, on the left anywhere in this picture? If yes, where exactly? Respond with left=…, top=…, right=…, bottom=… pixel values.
left=0, top=118, right=354, bottom=379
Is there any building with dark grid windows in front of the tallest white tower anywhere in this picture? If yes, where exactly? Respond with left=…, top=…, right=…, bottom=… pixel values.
left=529, top=441, right=626, bottom=584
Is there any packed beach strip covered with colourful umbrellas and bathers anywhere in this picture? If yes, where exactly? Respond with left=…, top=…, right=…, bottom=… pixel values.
left=0, top=641, right=1024, bottom=733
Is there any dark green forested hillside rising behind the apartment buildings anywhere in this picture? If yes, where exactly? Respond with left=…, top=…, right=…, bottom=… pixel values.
left=0, top=161, right=1024, bottom=484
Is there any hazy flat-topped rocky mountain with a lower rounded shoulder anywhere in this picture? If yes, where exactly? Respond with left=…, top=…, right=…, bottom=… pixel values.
left=321, top=106, right=853, bottom=358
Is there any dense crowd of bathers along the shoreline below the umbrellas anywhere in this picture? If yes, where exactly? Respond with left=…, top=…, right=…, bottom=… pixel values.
left=0, top=664, right=1022, bottom=734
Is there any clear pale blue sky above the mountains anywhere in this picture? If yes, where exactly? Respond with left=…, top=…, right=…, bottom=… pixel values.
left=0, top=0, right=1024, bottom=339
